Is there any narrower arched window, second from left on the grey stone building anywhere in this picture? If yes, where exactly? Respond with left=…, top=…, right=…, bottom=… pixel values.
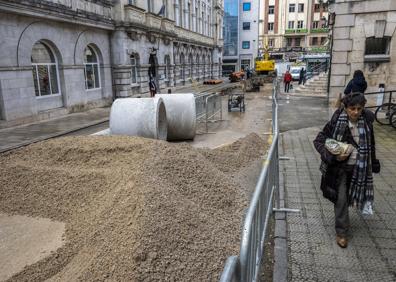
left=84, top=46, right=100, bottom=89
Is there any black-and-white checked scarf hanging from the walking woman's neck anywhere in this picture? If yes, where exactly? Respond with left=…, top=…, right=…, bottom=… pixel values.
left=320, top=110, right=374, bottom=209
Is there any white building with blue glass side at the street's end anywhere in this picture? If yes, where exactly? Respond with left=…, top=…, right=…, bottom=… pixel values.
left=223, top=0, right=259, bottom=74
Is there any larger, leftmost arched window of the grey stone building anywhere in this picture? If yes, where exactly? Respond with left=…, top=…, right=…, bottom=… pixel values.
left=31, top=41, right=60, bottom=97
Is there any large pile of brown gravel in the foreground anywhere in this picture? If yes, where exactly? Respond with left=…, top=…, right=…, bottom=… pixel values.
left=0, top=134, right=265, bottom=281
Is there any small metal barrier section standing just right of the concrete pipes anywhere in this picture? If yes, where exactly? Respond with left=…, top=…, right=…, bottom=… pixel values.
left=195, top=93, right=223, bottom=132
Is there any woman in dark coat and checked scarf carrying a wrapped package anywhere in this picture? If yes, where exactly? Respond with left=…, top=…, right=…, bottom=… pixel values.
left=313, top=93, right=380, bottom=248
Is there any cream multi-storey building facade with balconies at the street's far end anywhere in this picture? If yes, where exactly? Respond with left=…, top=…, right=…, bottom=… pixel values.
left=259, top=0, right=328, bottom=60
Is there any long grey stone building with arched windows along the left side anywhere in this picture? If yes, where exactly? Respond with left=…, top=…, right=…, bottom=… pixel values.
left=0, top=0, right=223, bottom=122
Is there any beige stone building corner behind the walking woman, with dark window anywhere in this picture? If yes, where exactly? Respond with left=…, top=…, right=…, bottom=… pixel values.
left=329, top=0, right=396, bottom=103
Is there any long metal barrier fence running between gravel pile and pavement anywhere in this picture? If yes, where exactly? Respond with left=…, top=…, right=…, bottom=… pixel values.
left=220, top=79, right=279, bottom=282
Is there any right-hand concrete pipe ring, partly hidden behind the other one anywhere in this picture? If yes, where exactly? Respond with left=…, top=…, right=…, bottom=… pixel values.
left=155, top=93, right=196, bottom=141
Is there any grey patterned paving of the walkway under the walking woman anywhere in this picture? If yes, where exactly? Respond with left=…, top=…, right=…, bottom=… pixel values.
left=280, top=95, right=396, bottom=281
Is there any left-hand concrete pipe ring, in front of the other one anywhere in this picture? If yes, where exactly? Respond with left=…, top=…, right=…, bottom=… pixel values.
left=110, top=98, right=168, bottom=140
